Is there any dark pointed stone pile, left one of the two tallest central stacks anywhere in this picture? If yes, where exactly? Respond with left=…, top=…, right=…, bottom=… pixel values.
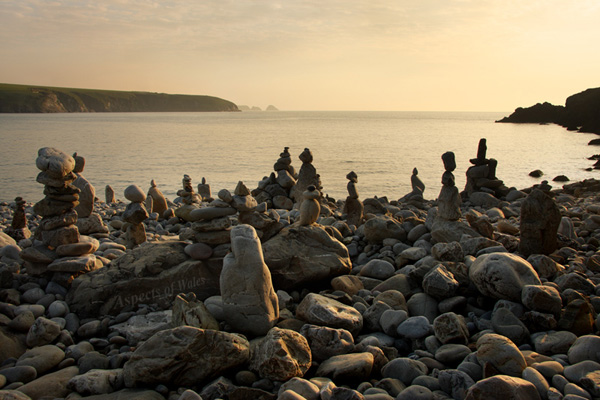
left=252, top=147, right=296, bottom=210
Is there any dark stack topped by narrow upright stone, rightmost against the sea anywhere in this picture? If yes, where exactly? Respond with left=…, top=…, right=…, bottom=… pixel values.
left=464, top=138, right=509, bottom=198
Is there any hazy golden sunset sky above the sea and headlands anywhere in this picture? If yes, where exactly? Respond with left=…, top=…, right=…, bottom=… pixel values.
left=0, top=0, right=600, bottom=111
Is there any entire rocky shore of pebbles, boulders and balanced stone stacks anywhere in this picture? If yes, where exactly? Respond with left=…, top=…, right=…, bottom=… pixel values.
left=0, top=147, right=600, bottom=400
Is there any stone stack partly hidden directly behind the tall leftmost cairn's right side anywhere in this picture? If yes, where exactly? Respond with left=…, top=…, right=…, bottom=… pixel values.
left=73, top=153, right=108, bottom=238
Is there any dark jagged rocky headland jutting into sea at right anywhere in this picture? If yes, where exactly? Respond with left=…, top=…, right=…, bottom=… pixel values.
left=496, top=88, right=600, bottom=134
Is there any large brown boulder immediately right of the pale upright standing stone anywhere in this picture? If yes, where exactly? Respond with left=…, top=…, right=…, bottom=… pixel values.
left=263, top=224, right=352, bottom=290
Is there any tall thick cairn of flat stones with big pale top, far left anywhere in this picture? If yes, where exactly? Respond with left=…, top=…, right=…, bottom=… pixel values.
left=21, top=147, right=103, bottom=287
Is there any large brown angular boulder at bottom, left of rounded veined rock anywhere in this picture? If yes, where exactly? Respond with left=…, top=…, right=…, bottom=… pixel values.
left=123, top=326, right=250, bottom=387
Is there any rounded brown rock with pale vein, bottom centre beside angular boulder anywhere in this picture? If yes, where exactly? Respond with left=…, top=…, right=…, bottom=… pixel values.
left=250, top=327, right=312, bottom=381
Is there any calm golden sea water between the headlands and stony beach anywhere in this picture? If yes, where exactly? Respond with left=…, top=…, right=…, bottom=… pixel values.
left=0, top=111, right=598, bottom=202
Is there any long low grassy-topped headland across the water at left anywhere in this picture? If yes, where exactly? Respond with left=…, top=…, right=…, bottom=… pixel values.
left=0, top=84, right=240, bottom=113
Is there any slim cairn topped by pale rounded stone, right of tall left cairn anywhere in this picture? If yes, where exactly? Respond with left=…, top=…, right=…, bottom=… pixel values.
left=122, top=185, right=148, bottom=249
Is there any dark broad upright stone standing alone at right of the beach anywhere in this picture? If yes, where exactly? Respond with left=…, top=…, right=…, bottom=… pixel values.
left=519, top=189, right=561, bottom=257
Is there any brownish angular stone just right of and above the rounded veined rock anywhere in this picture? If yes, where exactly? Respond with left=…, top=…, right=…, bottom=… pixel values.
left=300, top=324, right=354, bottom=361
